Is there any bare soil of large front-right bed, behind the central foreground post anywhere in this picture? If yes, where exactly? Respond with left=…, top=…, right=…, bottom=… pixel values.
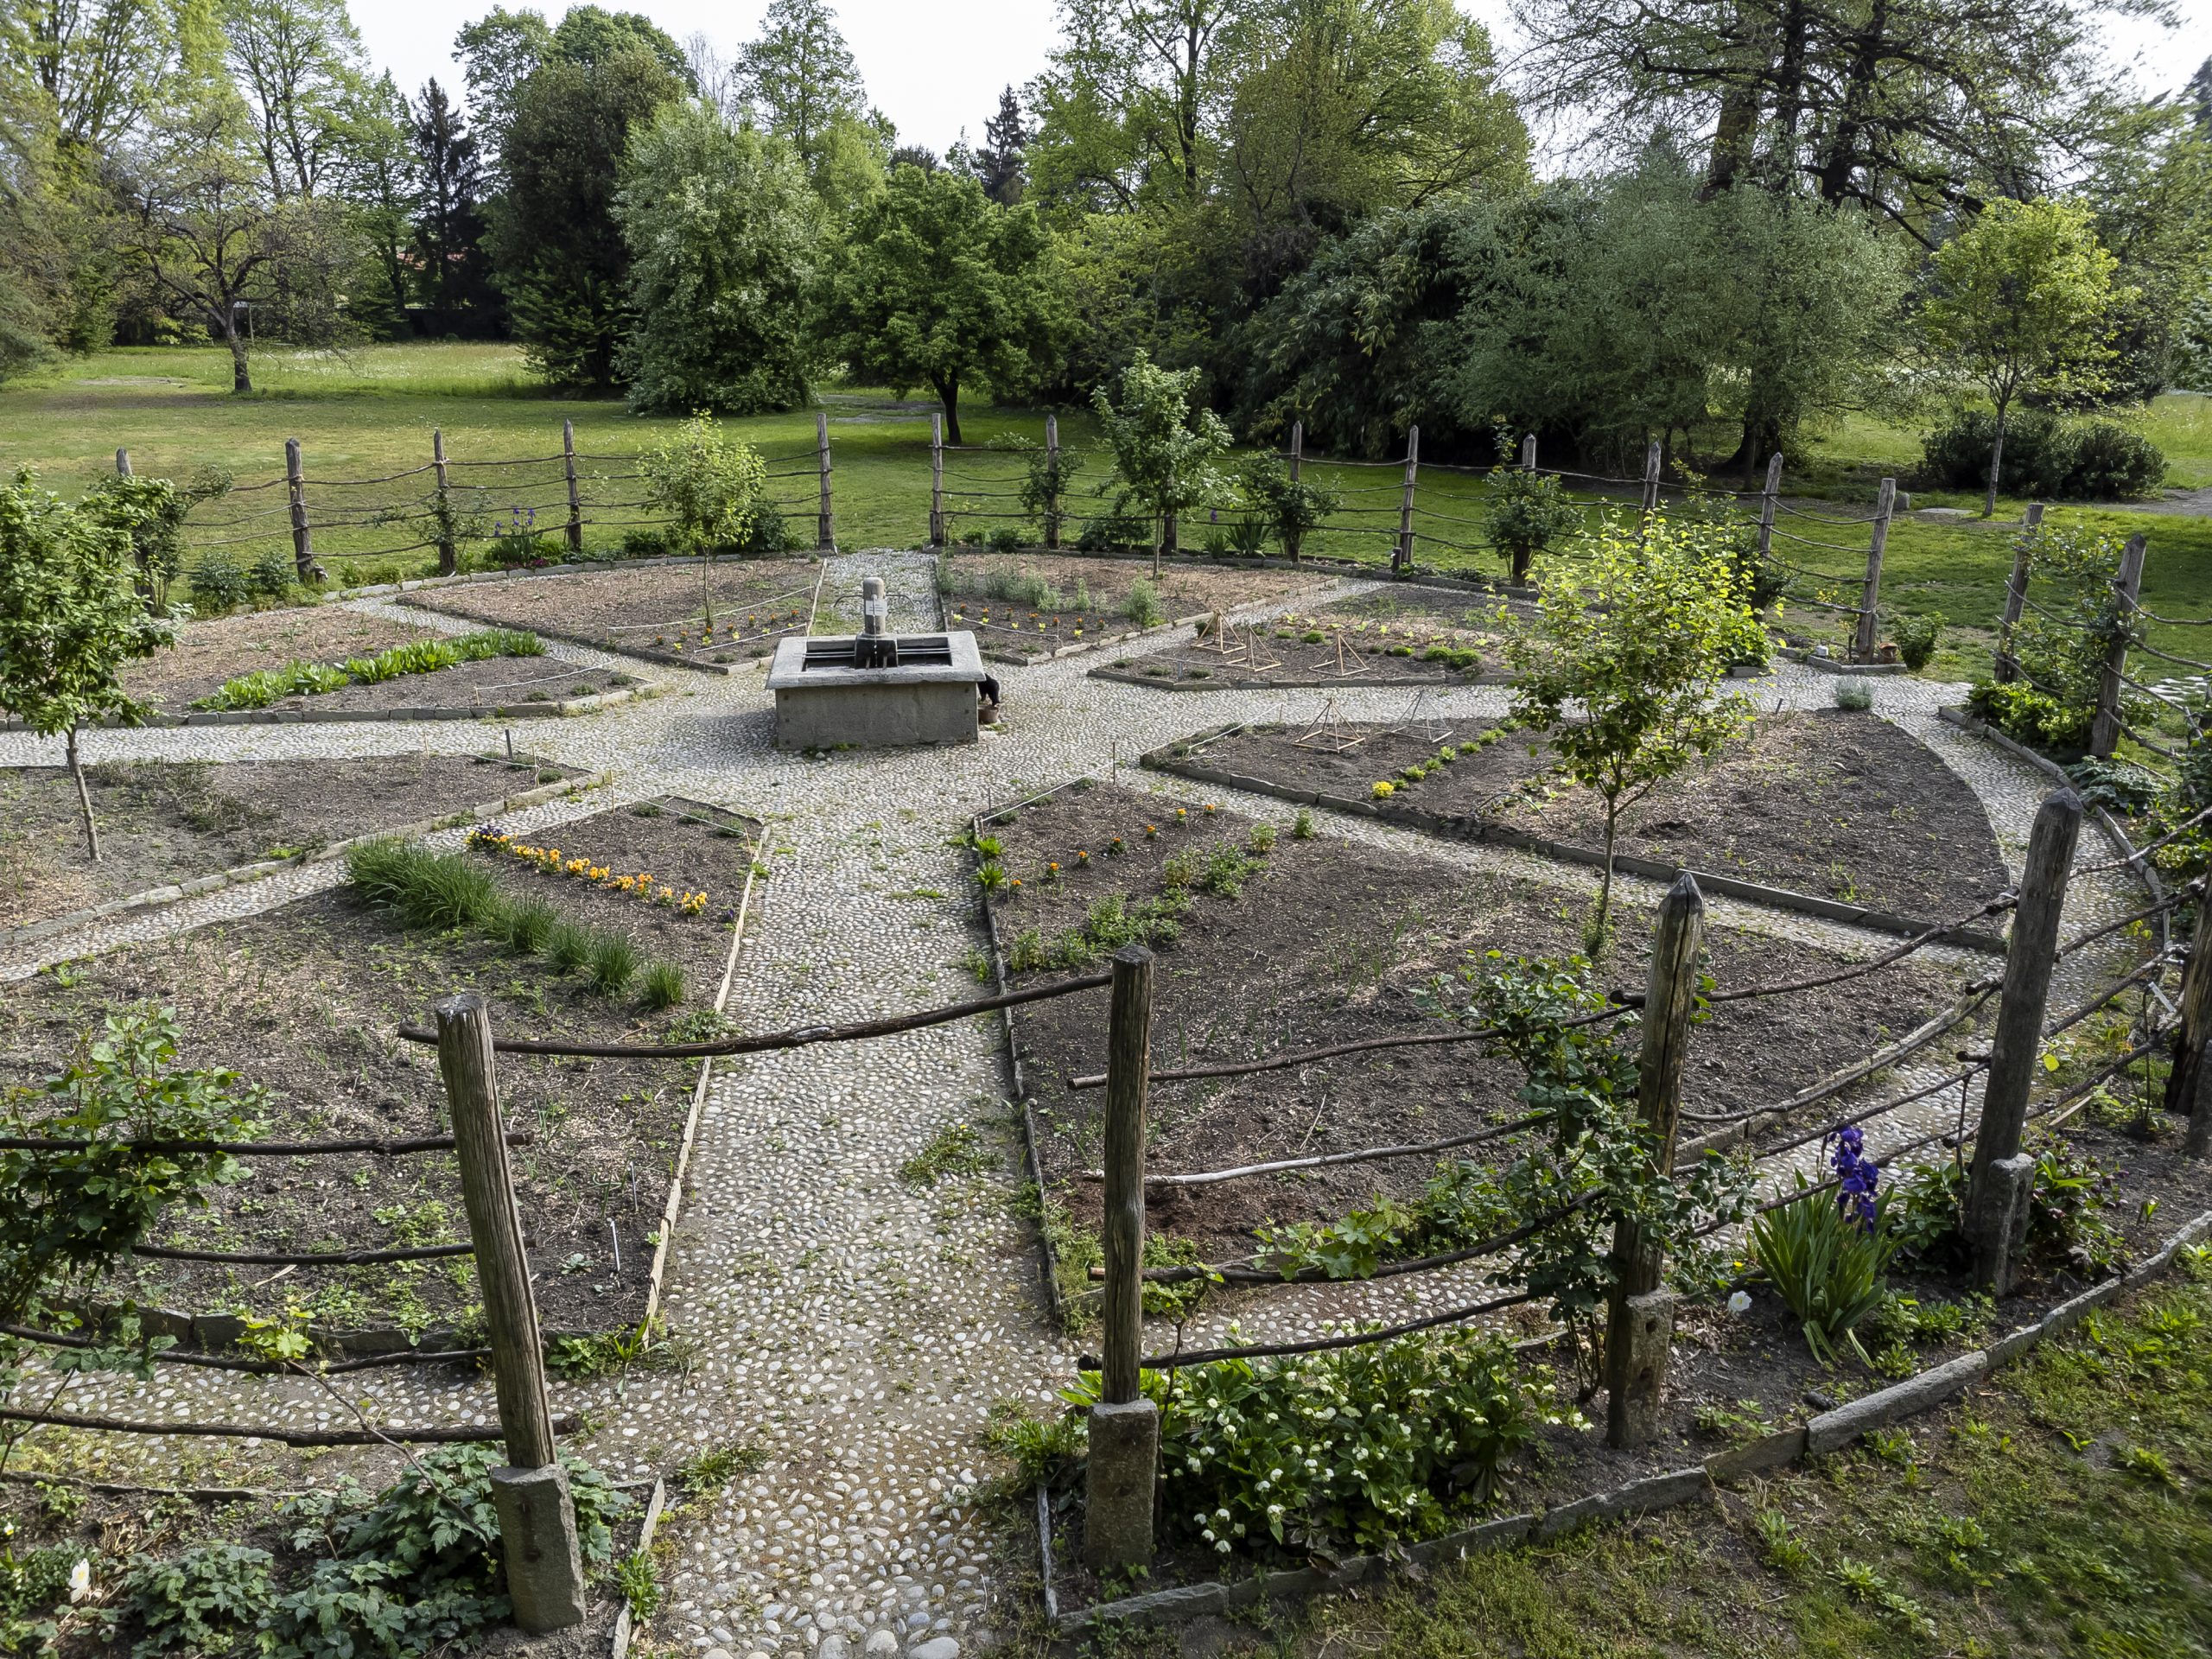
left=987, top=785, right=1955, bottom=1261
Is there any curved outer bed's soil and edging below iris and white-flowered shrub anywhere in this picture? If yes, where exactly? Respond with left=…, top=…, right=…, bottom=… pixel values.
left=1038, top=1185, right=2212, bottom=1630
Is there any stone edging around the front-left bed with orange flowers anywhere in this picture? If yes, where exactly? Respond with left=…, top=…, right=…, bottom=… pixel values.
left=54, top=800, right=766, bottom=1371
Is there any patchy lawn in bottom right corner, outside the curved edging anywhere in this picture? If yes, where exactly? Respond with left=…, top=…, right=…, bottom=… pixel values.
left=1093, top=1252, right=2212, bottom=1659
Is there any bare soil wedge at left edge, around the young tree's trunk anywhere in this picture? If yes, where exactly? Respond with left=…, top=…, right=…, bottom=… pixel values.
left=0, top=754, right=582, bottom=927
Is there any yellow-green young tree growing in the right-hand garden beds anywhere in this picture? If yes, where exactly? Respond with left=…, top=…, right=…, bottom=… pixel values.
left=1497, top=515, right=1765, bottom=956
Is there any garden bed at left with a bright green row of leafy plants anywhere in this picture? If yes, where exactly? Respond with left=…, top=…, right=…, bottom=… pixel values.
left=107, top=606, right=639, bottom=726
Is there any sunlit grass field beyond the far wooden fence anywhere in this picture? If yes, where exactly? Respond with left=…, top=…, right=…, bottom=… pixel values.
left=0, top=343, right=2212, bottom=672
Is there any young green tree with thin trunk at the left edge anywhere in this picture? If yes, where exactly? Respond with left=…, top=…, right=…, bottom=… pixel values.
left=0, top=469, right=170, bottom=862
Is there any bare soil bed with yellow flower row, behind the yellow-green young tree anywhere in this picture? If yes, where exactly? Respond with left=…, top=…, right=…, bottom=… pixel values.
left=1161, top=710, right=2006, bottom=923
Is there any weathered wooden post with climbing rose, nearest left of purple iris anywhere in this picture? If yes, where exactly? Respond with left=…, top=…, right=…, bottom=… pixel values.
left=1606, top=874, right=1706, bottom=1446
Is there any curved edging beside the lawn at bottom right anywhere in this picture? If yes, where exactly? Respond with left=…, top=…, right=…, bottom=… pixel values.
left=1038, top=1210, right=2212, bottom=1632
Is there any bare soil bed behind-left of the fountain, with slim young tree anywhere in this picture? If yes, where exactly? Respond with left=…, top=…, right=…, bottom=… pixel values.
left=403, top=557, right=817, bottom=671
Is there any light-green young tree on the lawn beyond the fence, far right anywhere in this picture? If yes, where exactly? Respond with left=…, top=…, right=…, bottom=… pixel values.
left=1920, top=197, right=2128, bottom=518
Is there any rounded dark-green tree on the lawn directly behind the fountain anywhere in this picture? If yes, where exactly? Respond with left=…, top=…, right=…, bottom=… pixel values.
left=825, top=166, right=1068, bottom=442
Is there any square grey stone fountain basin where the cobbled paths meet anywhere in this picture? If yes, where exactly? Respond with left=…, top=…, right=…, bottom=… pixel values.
left=767, top=632, right=987, bottom=750
